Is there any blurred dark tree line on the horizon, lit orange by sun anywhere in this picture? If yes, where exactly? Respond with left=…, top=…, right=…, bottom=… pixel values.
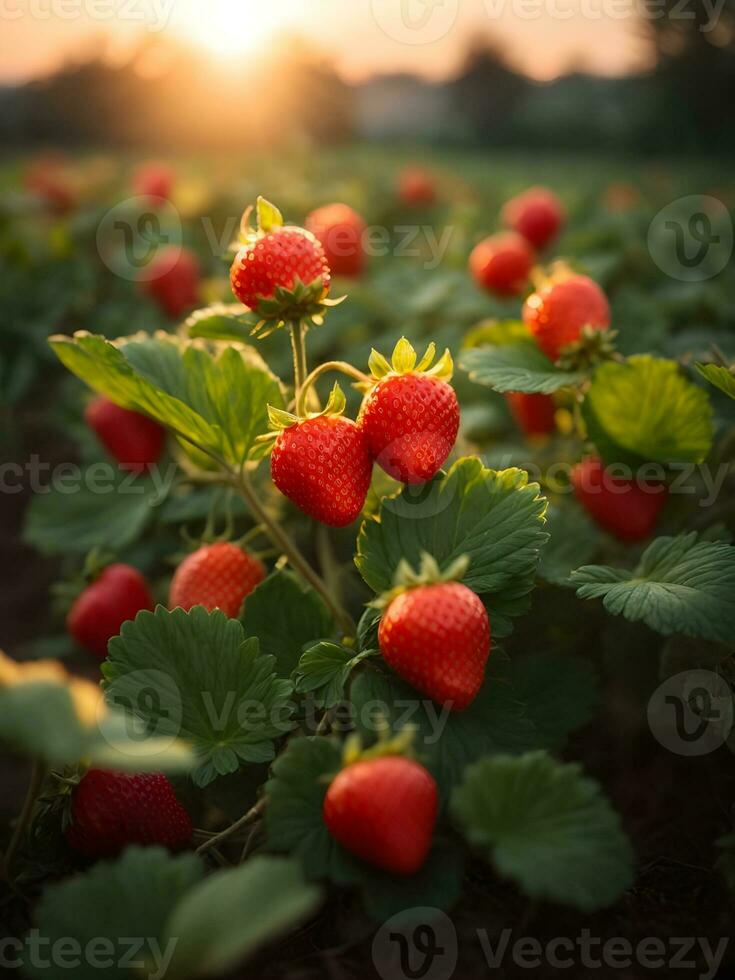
left=0, top=0, right=735, bottom=154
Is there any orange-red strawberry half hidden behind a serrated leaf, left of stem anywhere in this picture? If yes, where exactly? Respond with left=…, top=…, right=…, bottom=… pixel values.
left=168, top=541, right=265, bottom=619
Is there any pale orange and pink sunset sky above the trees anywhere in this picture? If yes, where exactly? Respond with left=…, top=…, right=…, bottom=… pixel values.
left=0, top=0, right=645, bottom=82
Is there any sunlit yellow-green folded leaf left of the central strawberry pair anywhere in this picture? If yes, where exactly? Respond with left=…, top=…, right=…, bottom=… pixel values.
left=50, top=332, right=283, bottom=466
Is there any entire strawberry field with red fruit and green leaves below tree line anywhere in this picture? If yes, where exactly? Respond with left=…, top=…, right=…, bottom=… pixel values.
left=0, top=145, right=735, bottom=980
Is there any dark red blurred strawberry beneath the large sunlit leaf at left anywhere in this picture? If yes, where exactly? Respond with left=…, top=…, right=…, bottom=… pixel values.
left=84, top=395, right=166, bottom=473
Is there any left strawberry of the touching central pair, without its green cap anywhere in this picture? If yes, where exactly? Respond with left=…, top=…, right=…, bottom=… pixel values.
left=271, top=415, right=373, bottom=527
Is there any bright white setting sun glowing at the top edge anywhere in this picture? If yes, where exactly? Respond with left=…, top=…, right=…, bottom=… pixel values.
left=176, top=0, right=303, bottom=58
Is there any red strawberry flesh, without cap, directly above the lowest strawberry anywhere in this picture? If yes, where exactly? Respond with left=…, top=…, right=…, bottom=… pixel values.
left=378, top=582, right=490, bottom=711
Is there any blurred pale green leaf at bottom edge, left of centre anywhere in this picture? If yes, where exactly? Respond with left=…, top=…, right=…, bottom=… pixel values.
left=166, top=856, right=320, bottom=980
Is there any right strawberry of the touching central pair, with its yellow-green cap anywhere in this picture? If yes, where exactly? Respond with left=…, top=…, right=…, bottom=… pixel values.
left=357, top=337, right=459, bottom=483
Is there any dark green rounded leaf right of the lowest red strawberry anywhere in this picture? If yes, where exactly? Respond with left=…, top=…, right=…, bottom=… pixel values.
left=452, top=752, right=633, bottom=912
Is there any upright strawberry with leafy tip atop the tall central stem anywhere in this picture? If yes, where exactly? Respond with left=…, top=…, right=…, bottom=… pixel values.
left=230, top=198, right=332, bottom=320
